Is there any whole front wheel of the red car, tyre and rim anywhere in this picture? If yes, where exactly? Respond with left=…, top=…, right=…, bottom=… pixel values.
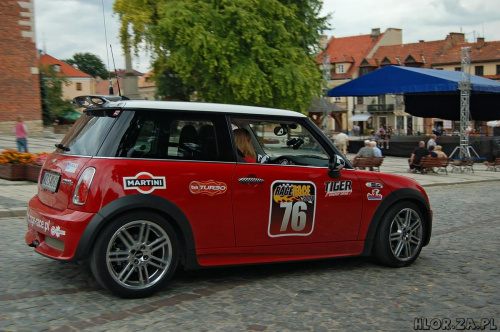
left=375, top=202, right=425, bottom=267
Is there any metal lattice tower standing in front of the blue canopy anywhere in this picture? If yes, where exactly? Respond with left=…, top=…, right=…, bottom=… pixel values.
left=450, top=47, right=479, bottom=159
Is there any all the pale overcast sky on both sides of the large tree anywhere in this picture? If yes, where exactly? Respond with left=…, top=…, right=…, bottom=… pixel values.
left=34, top=0, right=500, bottom=72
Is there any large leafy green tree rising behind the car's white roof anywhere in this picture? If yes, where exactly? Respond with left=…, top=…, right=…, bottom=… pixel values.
left=114, top=0, right=328, bottom=111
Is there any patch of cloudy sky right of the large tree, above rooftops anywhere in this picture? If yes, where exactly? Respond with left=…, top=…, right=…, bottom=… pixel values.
left=323, top=0, right=500, bottom=43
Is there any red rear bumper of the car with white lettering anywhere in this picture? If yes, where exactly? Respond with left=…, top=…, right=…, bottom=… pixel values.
left=25, top=196, right=95, bottom=261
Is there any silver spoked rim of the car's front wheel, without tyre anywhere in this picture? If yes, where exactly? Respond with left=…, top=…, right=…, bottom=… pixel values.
left=389, top=208, right=423, bottom=261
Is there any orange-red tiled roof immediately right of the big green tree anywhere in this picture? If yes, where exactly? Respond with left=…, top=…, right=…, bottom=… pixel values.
left=317, top=33, right=384, bottom=79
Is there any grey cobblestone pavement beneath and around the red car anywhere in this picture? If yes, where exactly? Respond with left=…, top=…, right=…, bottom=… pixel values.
left=0, top=182, right=500, bottom=332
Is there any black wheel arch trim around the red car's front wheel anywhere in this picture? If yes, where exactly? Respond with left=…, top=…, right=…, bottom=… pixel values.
left=362, top=188, right=432, bottom=256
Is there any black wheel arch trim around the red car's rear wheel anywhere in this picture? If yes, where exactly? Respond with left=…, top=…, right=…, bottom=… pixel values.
left=72, top=194, right=199, bottom=269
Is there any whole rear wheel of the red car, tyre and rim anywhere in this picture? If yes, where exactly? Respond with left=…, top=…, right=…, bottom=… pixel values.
left=90, top=211, right=179, bottom=298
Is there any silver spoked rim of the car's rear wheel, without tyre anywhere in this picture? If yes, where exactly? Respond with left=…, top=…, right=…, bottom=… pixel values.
left=106, top=220, right=172, bottom=290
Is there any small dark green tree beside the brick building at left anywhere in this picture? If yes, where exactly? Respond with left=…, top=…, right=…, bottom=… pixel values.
left=40, top=65, right=74, bottom=125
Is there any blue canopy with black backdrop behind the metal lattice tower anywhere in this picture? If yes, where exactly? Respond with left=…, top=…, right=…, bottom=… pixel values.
left=328, top=66, right=500, bottom=121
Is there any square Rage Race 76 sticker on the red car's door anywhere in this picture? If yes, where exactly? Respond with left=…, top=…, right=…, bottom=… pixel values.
left=268, top=181, right=316, bottom=237
